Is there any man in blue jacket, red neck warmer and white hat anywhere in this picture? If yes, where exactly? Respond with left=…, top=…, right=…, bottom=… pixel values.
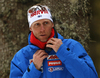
left=10, top=5, right=98, bottom=78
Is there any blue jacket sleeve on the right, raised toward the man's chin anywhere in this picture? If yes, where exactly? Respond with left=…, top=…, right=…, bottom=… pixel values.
left=56, top=39, right=98, bottom=78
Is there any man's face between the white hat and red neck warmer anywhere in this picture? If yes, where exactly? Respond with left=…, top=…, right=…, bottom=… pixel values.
left=30, top=19, right=54, bottom=42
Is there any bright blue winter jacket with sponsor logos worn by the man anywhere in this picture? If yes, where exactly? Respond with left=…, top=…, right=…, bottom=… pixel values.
left=10, top=34, right=98, bottom=78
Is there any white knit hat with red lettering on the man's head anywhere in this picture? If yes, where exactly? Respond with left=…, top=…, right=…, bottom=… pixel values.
left=28, top=6, right=53, bottom=27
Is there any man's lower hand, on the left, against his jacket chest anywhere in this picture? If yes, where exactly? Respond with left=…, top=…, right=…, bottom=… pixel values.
left=33, top=50, right=48, bottom=70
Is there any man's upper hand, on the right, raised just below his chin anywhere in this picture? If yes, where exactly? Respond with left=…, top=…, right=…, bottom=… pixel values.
left=46, top=38, right=63, bottom=52
